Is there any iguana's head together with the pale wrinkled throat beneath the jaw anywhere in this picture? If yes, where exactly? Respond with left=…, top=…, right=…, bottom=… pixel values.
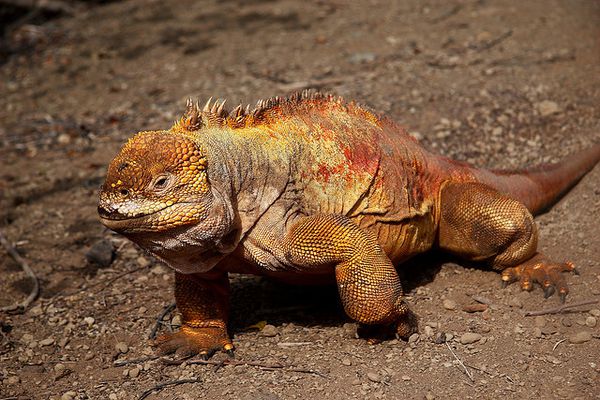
left=98, top=130, right=233, bottom=272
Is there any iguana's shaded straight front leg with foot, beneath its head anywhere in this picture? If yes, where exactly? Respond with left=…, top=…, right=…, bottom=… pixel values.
left=156, top=272, right=233, bottom=357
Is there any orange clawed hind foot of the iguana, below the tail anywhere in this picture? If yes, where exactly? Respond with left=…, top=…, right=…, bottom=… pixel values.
left=502, top=253, right=577, bottom=303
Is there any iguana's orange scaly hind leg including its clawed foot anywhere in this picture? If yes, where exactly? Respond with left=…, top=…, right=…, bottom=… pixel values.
left=439, top=183, right=575, bottom=301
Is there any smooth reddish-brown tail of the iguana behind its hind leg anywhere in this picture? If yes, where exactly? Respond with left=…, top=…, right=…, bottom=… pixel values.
left=474, top=144, right=600, bottom=215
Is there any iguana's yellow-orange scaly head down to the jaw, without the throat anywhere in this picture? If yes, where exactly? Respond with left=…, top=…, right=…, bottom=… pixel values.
left=98, top=131, right=212, bottom=233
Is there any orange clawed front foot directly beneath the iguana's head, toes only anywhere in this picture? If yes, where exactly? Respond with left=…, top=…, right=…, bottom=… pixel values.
left=154, top=325, right=233, bottom=359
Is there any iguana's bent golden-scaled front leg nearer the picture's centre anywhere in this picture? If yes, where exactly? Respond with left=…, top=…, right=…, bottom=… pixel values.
left=282, top=215, right=416, bottom=337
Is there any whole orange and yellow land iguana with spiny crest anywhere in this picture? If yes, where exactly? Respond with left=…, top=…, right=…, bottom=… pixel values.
left=98, top=91, right=600, bottom=356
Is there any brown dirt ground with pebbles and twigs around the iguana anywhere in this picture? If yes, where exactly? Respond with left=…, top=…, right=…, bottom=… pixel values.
left=0, top=0, right=600, bottom=400
